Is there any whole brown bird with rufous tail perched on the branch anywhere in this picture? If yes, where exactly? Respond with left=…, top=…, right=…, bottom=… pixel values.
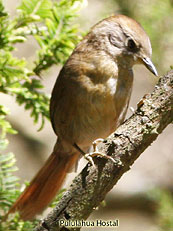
left=8, top=15, right=157, bottom=220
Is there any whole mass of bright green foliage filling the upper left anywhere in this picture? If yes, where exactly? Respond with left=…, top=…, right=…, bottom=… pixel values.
left=0, top=0, right=83, bottom=128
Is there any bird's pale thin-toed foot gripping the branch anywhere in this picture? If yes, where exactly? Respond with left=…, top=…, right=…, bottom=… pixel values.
left=84, top=138, right=116, bottom=167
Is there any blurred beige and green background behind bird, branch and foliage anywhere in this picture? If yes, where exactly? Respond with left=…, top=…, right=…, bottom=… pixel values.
left=0, top=0, right=173, bottom=231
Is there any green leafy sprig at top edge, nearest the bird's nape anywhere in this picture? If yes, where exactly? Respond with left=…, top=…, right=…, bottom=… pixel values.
left=34, top=1, right=83, bottom=75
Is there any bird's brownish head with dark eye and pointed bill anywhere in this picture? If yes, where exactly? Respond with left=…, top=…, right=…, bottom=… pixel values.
left=91, top=15, right=158, bottom=76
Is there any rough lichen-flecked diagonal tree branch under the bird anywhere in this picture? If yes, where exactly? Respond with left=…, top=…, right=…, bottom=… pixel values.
left=36, top=70, right=173, bottom=231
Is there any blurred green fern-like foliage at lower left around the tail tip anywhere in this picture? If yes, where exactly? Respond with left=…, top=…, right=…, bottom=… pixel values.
left=0, top=137, right=38, bottom=231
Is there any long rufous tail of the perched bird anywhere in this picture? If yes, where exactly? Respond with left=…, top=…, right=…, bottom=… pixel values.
left=6, top=143, right=78, bottom=220
